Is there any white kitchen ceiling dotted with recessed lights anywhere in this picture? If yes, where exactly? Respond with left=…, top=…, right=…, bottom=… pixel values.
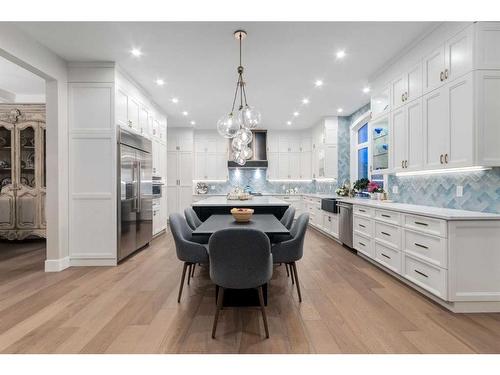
left=15, top=22, right=434, bottom=129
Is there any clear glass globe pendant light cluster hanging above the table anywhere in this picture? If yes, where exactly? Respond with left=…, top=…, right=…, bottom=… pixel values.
left=217, top=30, right=261, bottom=166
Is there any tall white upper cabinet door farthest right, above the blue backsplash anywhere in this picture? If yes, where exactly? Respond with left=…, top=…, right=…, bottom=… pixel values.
left=445, top=72, right=474, bottom=167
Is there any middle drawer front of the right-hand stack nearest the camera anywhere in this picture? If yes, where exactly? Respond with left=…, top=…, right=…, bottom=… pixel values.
left=403, top=229, right=448, bottom=268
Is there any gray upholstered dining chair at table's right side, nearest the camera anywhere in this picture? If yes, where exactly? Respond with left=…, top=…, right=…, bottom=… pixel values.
left=271, top=214, right=309, bottom=302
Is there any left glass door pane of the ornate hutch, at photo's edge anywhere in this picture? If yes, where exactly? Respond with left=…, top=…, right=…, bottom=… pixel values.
left=0, top=124, right=15, bottom=229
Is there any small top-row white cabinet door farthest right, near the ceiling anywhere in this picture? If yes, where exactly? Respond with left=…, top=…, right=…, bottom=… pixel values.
left=445, top=25, right=474, bottom=82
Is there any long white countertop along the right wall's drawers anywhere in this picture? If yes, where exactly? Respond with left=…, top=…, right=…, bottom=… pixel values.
left=339, top=197, right=500, bottom=220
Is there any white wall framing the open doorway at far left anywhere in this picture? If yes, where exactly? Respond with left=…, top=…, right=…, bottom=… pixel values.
left=0, top=23, right=68, bottom=271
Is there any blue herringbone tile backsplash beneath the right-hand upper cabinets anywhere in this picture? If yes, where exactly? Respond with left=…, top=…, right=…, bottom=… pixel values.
left=387, top=168, right=500, bottom=213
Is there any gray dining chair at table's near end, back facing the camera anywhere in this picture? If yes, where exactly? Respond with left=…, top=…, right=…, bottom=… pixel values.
left=208, top=228, right=273, bottom=338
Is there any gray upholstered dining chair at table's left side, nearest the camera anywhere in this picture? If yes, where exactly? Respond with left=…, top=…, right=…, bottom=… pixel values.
left=169, top=213, right=208, bottom=302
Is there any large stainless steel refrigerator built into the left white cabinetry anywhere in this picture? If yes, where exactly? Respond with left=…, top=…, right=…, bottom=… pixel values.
left=118, top=129, right=153, bottom=260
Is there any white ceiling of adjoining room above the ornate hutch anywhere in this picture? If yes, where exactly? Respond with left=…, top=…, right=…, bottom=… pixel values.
left=0, top=57, right=45, bottom=95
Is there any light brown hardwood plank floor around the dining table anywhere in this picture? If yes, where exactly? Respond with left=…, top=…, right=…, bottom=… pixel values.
left=0, top=230, right=500, bottom=353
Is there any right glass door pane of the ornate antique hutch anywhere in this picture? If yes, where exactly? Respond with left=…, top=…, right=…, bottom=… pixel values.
left=16, top=124, right=37, bottom=228
